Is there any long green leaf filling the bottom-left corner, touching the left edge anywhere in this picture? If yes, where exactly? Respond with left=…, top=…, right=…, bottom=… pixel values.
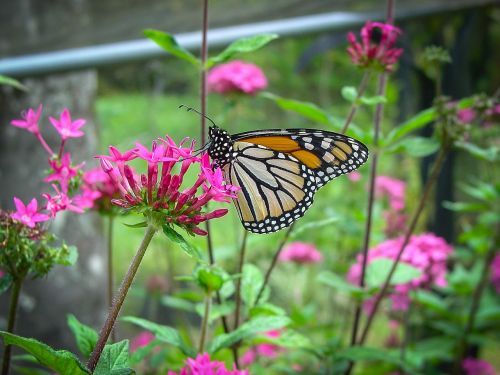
left=0, top=331, right=89, bottom=375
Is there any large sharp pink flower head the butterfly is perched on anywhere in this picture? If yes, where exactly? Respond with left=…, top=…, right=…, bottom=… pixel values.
left=100, top=140, right=237, bottom=235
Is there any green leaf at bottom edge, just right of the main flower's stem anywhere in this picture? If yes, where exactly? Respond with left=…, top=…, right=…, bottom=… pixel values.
left=94, top=340, right=134, bottom=375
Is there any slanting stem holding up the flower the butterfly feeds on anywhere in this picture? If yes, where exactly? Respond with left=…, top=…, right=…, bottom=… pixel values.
left=87, top=224, right=156, bottom=373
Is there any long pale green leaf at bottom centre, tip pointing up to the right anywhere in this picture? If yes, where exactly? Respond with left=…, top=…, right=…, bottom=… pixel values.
left=208, top=316, right=290, bottom=354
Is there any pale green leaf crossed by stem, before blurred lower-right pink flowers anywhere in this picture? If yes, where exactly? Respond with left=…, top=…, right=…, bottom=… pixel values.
left=366, top=258, right=422, bottom=287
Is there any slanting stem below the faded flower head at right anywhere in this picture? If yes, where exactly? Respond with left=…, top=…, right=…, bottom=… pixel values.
left=357, top=146, right=448, bottom=345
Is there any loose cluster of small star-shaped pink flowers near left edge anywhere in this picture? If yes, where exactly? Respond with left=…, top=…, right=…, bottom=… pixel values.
left=11, top=105, right=97, bottom=228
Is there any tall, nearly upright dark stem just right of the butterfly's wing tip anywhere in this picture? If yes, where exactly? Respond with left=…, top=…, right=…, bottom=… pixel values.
left=346, top=73, right=387, bottom=358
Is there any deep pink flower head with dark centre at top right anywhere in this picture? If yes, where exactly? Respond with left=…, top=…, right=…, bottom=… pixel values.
left=347, top=21, right=403, bottom=72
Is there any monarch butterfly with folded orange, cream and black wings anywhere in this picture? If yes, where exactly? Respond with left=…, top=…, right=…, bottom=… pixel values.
left=207, top=124, right=368, bottom=233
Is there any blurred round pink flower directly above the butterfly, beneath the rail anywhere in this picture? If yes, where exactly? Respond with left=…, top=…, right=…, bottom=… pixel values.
left=207, top=60, right=267, bottom=94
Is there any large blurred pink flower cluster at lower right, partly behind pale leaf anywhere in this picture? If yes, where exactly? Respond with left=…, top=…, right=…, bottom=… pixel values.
left=347, top=233, right=453, bottom=310
